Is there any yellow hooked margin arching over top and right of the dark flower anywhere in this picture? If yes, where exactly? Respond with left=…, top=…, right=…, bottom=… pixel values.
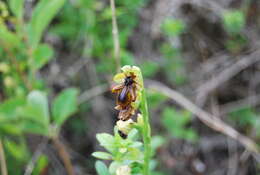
left=113, top=65, right=144, bottom=109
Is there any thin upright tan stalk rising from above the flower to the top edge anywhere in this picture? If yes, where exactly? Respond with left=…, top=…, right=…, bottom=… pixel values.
left=110, top=0, right=121, bottom=72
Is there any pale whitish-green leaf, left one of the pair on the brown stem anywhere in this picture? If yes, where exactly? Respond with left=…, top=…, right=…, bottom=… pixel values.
left=20, top=91, right=50, bottom=127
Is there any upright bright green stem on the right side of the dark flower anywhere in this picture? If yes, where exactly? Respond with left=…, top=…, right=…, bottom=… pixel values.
left=140, top=89, right=151, bottom=175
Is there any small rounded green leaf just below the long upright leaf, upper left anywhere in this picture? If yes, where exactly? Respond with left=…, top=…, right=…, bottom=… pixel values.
left=32, top=44, right=53, bottom=70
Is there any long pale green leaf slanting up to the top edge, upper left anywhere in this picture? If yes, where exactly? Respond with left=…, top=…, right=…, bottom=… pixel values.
left=28, top=0, right=65, bottom=48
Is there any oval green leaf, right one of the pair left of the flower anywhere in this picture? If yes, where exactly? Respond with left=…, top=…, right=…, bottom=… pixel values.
left=52, top=88, right=78, bottom=126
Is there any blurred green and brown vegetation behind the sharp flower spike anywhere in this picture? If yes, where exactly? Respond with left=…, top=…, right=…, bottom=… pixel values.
left=0, top=0, right=260, bottom=175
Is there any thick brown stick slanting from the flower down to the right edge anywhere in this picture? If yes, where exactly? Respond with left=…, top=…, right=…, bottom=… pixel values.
left=148, top=82, right=259, bottom=153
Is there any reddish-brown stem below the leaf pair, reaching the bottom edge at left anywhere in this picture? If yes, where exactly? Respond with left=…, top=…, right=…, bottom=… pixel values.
left=52, top=137, right=75, bottom=175
